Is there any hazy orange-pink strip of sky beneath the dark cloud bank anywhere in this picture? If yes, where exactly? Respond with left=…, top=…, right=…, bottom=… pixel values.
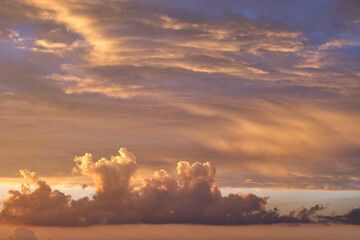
left=0, top=225, right=360, bottom=240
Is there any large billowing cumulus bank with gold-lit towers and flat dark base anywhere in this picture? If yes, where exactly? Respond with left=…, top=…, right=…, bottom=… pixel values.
left=0, top=148, right=323, bottom=226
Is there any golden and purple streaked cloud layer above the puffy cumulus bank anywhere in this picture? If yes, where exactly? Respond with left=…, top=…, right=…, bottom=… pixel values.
left=0, top=0, right=360, bottom=193
